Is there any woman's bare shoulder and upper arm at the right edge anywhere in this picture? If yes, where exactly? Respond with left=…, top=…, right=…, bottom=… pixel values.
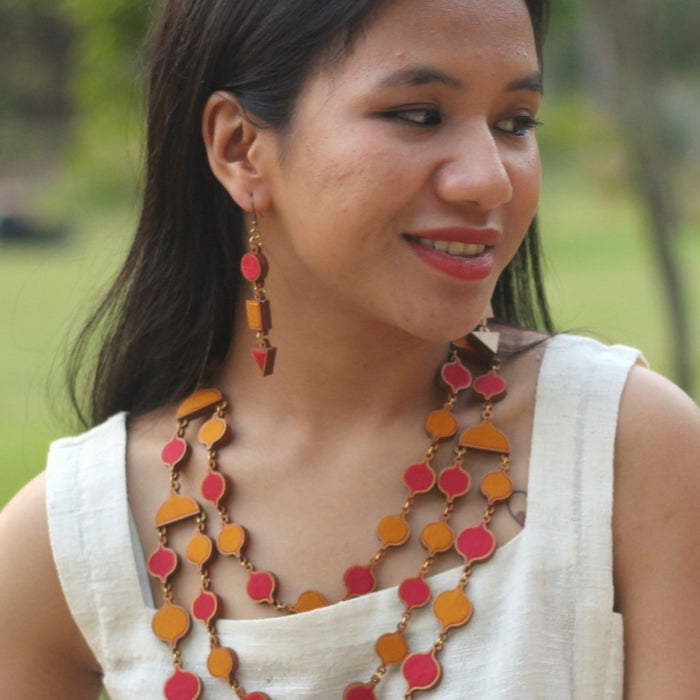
left=614, top=367, right=700, bottom=699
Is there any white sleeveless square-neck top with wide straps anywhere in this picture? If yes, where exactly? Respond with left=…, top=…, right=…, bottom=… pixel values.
left=47, top=335, right=639, bottom=700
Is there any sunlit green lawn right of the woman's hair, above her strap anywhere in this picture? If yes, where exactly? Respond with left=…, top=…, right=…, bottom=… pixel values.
left=541, top=167, right=700, bottom=382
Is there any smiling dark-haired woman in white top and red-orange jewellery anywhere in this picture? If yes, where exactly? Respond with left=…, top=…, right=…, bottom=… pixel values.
left=0, top=0, right=700, bottom=700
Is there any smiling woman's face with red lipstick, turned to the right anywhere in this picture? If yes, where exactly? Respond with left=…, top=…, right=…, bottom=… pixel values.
left=254, top=0, right=541, bottom=341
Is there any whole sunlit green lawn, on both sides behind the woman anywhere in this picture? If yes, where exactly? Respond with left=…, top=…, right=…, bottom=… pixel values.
left=0, top=171, right=700, bottom=504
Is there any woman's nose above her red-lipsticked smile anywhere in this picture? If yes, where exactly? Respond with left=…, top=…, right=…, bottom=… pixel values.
left=435, top=124, right=513, bottom=211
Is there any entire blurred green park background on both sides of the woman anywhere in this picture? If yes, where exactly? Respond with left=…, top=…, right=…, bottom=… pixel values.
left=0, top=0, right=700, bottom=505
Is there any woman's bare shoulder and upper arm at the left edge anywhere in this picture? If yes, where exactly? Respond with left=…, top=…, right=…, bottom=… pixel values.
left=0, top=474, right=101, bottom=700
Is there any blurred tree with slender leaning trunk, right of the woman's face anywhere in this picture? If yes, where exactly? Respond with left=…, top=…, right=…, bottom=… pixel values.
left=579, top=0, right=700, bottom=390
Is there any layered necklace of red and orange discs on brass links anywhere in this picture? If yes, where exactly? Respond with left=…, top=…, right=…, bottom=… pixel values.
left=148, top=324, right=513, bottom=700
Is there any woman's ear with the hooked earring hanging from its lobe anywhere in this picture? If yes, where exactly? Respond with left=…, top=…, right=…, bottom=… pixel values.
left=202, top=92, right=270, bottom=212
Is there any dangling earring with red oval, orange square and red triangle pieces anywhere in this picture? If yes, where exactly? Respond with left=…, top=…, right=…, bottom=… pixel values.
left=241, top=208, right=277, bottom=377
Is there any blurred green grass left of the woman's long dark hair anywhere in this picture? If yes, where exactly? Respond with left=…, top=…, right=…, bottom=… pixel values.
left=0, top=202, right=133, bottom=506
